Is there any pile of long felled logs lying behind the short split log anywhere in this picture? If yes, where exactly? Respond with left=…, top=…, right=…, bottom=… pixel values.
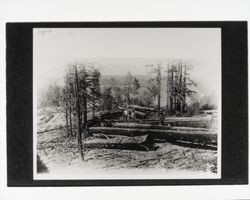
left=86, top=115, right=217, bottom=150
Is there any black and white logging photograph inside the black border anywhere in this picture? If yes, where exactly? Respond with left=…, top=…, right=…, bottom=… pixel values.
left=33, top=27, right=222, bottom=180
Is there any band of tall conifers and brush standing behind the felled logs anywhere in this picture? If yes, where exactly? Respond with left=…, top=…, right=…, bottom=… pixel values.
left=39, top=61, right=215, bottom=116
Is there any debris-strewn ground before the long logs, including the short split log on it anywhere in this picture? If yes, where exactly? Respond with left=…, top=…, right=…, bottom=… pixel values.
left=37, top=110, right=217, bottom=178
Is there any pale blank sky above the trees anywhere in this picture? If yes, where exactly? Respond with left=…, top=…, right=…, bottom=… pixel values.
left=33, top=28, right=221, bottom=103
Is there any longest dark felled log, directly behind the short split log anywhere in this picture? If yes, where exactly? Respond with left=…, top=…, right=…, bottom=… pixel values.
left=89, top=127, right=217, bottom=145
